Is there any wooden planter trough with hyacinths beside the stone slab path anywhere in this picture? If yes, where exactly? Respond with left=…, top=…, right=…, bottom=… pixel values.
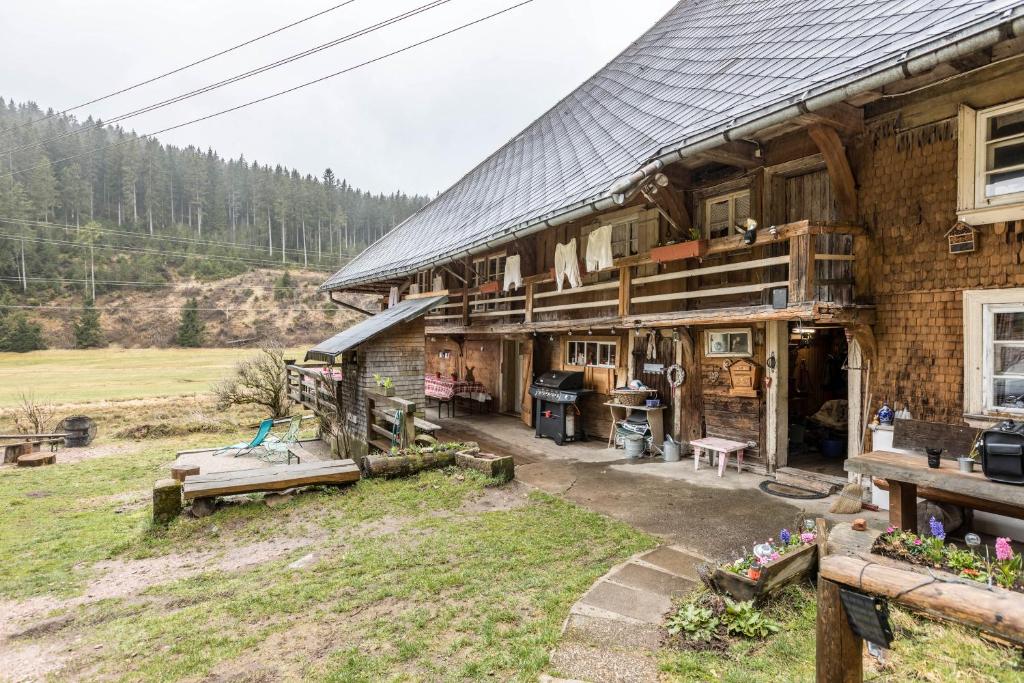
left=712, top=520, right=818, bottom=600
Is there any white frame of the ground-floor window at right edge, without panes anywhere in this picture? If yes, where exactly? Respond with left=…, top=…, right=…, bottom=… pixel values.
left=964, top=288, right=1024, bottom=427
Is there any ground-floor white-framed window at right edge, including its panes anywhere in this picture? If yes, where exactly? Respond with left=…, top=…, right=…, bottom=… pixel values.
left=964, top=288, right=1024, bottom=427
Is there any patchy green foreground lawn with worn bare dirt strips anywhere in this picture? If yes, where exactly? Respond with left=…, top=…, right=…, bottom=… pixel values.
left=0, top=441, right=654, bottom=681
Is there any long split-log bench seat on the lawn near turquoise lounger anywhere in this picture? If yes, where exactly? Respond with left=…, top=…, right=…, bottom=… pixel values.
left=184, top=460, right=359, bottom=511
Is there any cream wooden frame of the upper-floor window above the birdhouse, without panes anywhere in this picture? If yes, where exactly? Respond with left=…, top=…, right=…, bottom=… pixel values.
left=956, top=99, right=1024, bottom=225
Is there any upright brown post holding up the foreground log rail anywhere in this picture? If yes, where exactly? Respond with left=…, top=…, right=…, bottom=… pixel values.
left=815, top=577, right=864, bottom=683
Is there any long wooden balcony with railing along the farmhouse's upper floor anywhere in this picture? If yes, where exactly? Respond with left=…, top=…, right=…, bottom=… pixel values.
left=426, top=221, right=871, bottom=334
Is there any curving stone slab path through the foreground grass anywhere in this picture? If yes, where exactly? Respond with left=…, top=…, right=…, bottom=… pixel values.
left=541, top=546, right=706, bottom=683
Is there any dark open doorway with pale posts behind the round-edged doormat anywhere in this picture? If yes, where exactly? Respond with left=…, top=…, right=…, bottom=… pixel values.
left=787, top=324, right=849, bottom=477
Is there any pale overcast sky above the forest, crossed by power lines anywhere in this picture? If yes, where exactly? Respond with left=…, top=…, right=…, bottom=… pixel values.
left=6, top=0, right=675, bottom=195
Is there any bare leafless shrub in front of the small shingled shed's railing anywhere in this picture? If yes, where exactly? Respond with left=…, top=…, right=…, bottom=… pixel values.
left=213, top=343, right=289, bottom=419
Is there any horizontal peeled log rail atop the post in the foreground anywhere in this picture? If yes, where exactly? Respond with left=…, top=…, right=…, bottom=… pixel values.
left=819, top=555, right=1024, bottom=647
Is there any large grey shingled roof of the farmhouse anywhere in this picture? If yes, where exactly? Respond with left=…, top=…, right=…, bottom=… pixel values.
left=322, top=0, right=1024, bottom=290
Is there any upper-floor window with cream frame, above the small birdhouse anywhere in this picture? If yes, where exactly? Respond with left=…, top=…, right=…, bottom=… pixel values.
left=957, top=100, right=1024, bottom=225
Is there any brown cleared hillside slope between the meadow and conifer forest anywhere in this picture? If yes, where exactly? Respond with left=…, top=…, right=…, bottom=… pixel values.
left=30, top=269, right=373, bottom=348
